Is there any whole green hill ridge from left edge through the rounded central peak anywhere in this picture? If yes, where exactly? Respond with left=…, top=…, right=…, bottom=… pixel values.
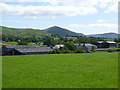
left=0, top=26, right=83, bottom=37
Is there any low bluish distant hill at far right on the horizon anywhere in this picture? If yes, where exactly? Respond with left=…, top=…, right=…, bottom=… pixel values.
left=87, top=33, right=118, bottom=38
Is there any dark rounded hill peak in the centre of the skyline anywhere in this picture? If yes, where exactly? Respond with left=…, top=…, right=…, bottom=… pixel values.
left=44, top=26, right=83, bottom=36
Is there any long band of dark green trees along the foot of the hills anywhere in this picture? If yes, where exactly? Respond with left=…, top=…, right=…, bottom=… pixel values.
left=2, top=34, right=116, bottom=47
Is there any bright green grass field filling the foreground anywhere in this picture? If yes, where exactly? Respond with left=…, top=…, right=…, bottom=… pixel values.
left=2, top=52, right=118, bottom=88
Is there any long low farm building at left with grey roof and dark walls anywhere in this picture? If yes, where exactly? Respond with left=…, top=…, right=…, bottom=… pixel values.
left=2, top=45, right=53, bottom=55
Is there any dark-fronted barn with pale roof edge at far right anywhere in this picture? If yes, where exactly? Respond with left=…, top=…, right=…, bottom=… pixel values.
left=94, top=41, right=117, bottom=48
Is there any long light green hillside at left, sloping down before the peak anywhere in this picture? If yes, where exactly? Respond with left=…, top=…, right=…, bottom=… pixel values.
left=0, top=26, right=50, bottom=37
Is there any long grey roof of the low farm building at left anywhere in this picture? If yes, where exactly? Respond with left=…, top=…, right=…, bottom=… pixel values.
left=3, top=45, right=53, bottom=53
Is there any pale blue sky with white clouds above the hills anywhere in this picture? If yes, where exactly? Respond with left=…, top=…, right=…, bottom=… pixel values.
left=0, top=0, right=118, bottom=35
